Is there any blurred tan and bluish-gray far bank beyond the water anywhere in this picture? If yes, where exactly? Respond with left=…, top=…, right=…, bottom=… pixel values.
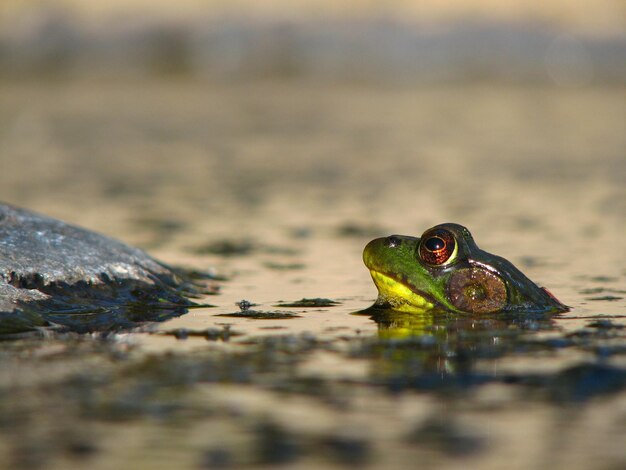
left=0, top=0, right=626, bottom=82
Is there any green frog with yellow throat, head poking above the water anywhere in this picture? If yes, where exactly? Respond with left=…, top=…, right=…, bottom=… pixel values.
left=363, top=223, right=569, bottom=315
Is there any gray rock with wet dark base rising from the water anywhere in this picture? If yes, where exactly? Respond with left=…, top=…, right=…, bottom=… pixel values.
left=0, top=204, right=211, bottom=334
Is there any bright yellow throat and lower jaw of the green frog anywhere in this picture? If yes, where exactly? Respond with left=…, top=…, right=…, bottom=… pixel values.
left=370, top=269, right=437, bottom=313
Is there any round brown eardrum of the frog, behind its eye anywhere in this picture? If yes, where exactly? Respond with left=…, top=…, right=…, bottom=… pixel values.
left=447, top=267, right=507, bottom=313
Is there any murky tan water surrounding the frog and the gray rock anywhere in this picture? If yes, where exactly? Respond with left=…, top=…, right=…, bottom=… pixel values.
left=0, top=81, right=626, bottom=469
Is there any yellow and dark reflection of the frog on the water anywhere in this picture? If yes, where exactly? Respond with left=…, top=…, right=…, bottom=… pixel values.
left=361, top=308, right=554, bottom=390
